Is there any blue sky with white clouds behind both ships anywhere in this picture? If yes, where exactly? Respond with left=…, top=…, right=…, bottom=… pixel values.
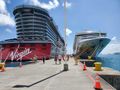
left=0, top=0, right=120, bottom=54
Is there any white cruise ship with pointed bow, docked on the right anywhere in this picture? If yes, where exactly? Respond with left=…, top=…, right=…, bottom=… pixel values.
left=73, top=31, right=110, bottom=58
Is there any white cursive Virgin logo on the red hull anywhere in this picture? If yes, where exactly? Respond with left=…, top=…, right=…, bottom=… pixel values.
left=9, top=48, right=32, bottom=61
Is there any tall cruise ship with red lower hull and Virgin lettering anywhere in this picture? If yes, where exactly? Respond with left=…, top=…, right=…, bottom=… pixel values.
left=0, top=5, right=65, bottom=61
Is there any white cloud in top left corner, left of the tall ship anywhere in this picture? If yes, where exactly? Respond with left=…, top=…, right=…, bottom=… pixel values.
left=0, top=0, right=15, bottom=26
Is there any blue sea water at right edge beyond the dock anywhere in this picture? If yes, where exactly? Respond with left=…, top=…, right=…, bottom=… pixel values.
left=96, top=53, right=120, bottom=71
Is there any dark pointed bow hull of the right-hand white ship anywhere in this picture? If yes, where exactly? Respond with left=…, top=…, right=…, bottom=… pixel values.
left=75, top=37, right=110, bottom=58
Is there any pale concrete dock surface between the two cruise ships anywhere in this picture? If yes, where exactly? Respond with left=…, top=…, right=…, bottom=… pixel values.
left=0, top=58, right=116, bottom=90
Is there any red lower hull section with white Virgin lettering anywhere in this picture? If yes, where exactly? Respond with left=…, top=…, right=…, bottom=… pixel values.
left=0, top=43, right=51, bottom=61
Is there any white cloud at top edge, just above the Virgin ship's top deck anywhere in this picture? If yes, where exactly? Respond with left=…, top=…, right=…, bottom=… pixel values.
left=25, top=0, right=59, bottom=10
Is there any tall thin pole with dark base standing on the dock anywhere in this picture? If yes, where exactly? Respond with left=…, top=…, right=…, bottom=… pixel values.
left=64, top=0, right=68, bottom=71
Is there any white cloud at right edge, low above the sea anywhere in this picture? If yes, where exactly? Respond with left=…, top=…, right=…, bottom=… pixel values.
left=101, top=37, right=120, bottom=54
